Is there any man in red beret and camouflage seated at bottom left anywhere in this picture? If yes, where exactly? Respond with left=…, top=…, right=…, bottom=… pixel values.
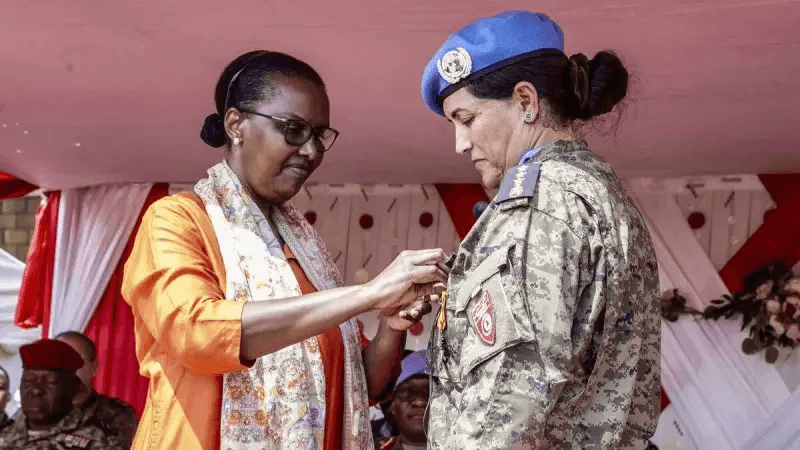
left=0, top=339, right=124, bottom=450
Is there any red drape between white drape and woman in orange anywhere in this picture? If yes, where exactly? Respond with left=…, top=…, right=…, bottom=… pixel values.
left=84, top=183, right=169, bottom=416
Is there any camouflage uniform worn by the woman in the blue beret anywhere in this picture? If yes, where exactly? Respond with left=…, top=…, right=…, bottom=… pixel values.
left=428, top=141, right=661, bottom=449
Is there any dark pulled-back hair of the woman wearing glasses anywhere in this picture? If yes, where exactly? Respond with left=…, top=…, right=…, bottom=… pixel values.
left=200, top=50, right=325, bottom=148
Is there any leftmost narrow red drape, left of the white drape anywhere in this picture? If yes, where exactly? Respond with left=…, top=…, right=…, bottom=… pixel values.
left=14, top=191, right=61, bottom=337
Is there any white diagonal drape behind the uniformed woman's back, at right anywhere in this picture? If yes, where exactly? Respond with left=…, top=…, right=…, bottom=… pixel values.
left=630, top=180, right=790, bottom=450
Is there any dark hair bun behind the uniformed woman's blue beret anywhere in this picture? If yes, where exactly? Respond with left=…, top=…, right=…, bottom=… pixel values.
left=565, top=51, right=628, bottom=120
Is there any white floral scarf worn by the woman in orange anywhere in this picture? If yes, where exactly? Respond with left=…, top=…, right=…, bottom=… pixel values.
left=194, top=162, right=373, bottom=450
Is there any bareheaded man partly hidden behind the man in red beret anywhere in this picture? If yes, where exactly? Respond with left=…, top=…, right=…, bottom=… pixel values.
left=56, top=331, right=139, bottom=448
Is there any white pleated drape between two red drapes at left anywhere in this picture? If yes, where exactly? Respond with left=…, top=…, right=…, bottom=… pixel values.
left=48, top=183, right=152, bottom=336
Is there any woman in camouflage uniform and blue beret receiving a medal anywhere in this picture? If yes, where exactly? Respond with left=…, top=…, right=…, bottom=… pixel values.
left=422, top=11, right=660, bottom=449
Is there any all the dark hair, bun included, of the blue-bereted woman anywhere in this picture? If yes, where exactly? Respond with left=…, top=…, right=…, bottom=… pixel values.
left=465, top=50, right=628, bottom=127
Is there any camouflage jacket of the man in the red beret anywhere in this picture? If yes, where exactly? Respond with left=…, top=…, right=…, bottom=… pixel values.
left=0, top=408, right=130, bottom=450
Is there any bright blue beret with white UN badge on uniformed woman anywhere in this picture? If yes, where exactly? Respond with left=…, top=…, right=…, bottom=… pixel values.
left=422, top=11, right=564, bottom=116
